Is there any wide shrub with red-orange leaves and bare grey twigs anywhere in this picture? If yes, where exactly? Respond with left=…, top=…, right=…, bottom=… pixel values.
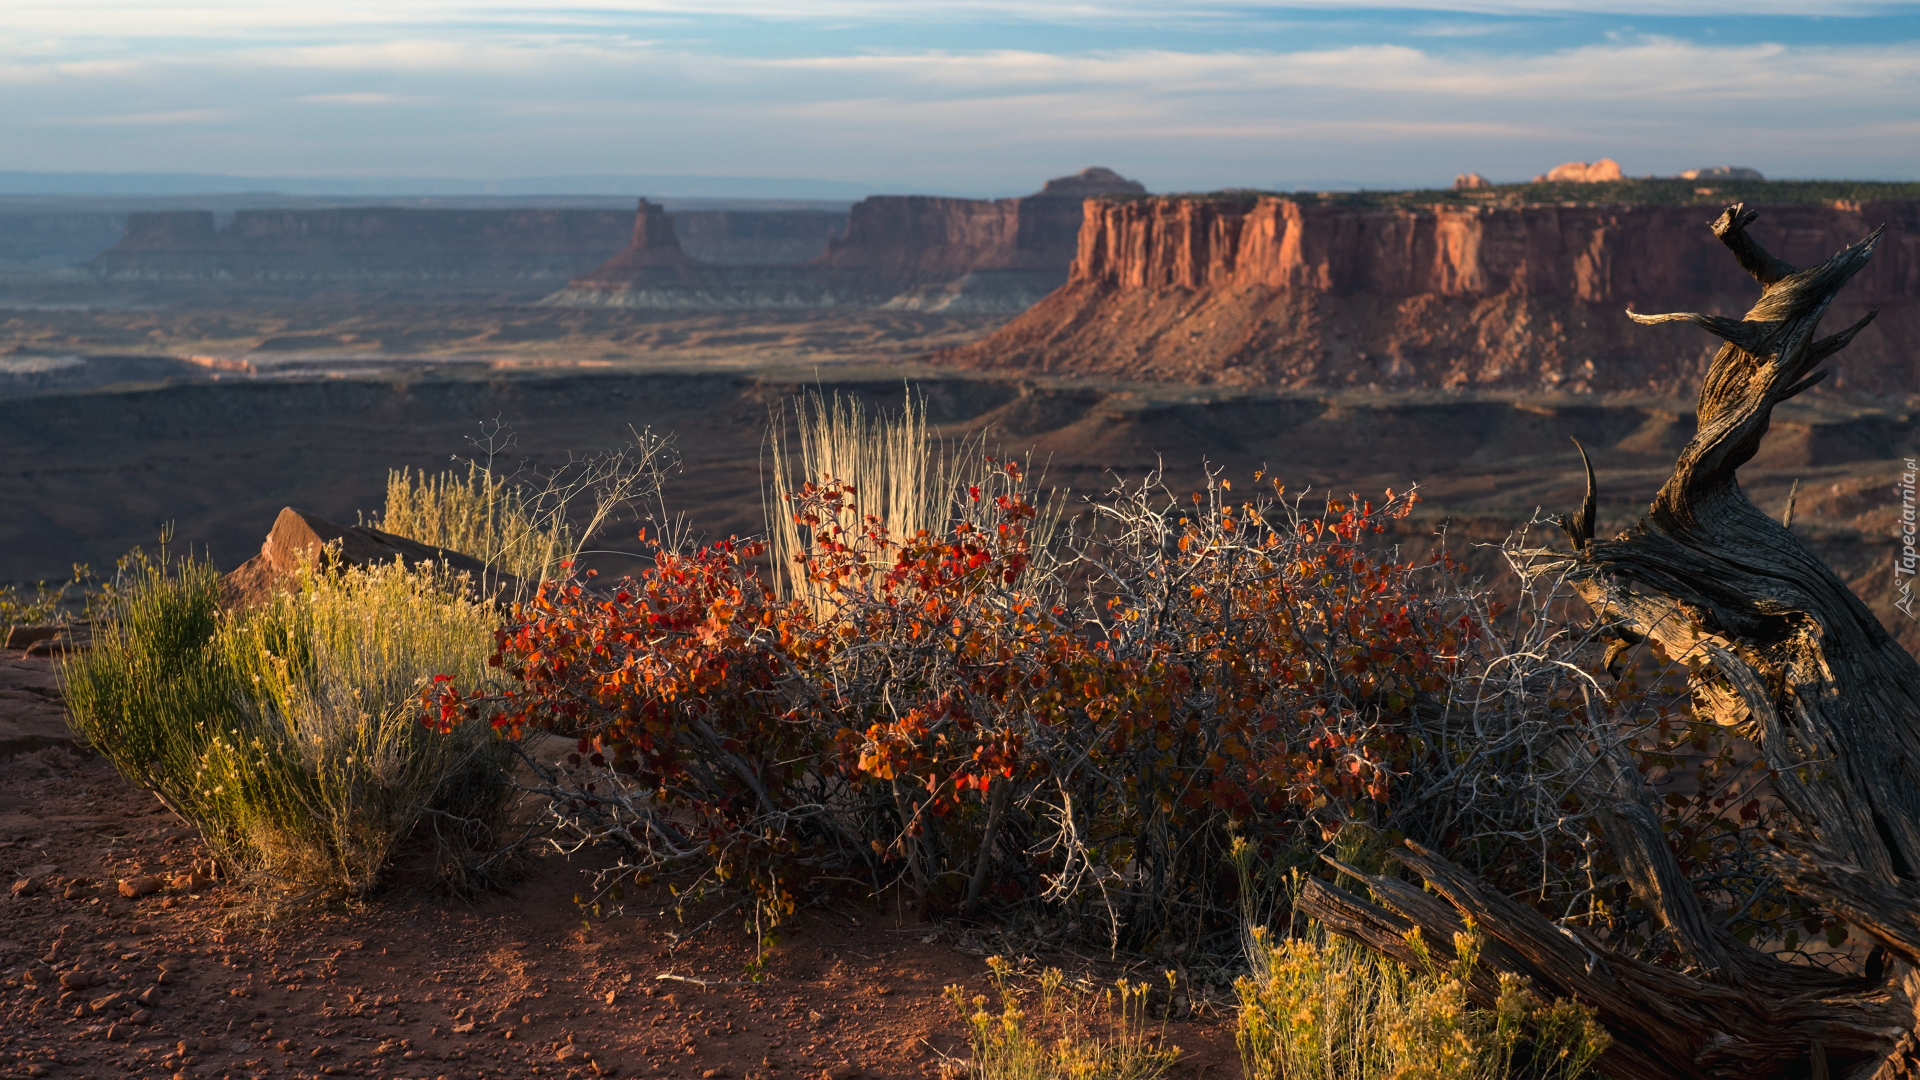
left=422, top=457, right=1820, bottom=947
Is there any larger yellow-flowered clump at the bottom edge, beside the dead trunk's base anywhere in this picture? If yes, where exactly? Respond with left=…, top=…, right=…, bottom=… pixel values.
left=1235, top=914, right=1609, bottom=1080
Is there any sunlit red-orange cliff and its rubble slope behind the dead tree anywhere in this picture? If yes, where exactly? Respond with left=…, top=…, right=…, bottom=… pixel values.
left=941, top=196, right=1920, bottom=396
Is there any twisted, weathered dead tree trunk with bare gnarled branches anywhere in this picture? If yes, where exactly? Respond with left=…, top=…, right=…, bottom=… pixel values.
left=1304, top=204, right=1920, bottom=1080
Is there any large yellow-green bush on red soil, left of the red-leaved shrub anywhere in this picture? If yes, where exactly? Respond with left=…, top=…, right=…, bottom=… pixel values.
left=61, top=545, right=507, bottom=896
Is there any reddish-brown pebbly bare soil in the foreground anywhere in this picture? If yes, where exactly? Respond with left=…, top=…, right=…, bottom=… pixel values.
left=0, top=653, right=1238, bottom=1080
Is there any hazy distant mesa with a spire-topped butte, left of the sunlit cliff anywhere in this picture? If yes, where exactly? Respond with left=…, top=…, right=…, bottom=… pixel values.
left=547, top=169, right=1146, bottom=311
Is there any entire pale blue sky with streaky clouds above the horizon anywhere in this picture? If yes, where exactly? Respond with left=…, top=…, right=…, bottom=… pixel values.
left=0, top=0, right=1920, bottom=198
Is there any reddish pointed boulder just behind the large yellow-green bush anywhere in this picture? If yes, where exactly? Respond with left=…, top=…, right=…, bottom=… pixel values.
left=221, top=507, right=520, bottom=611
